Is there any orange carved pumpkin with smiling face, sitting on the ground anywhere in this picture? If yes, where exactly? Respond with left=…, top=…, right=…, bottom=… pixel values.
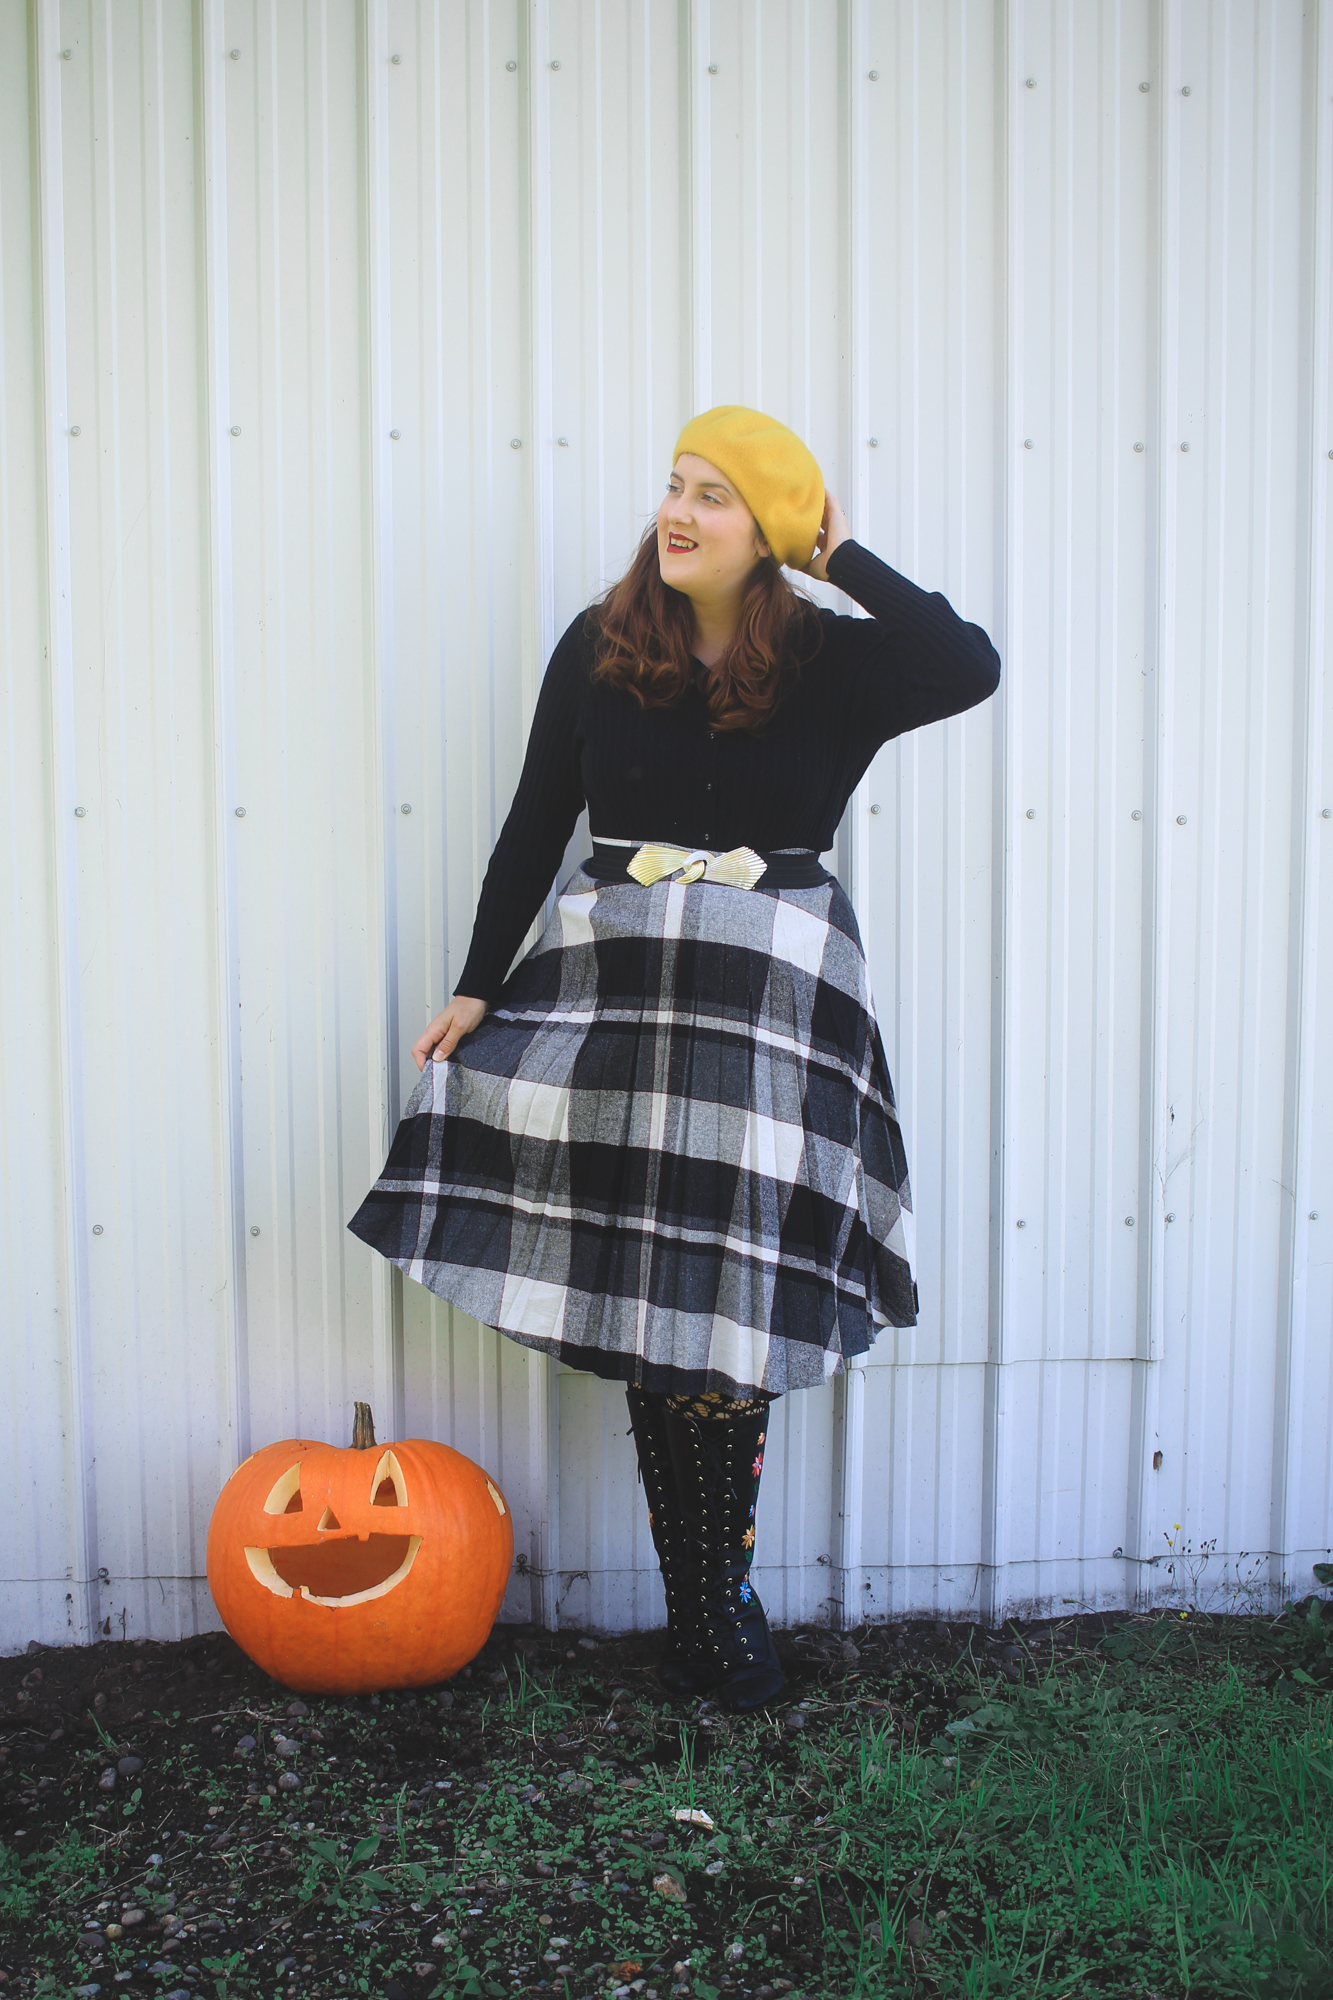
left=208, top=1402, right=514, bottom=1694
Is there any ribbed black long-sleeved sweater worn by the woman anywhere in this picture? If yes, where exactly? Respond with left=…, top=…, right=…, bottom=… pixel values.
left=454, top=540, right=1001, bottom=1002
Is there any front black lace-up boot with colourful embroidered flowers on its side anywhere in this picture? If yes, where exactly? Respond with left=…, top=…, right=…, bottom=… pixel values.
left=664, top=1410, right=785, bottom=1710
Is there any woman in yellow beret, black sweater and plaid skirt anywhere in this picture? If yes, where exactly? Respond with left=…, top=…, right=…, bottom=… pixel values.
left=350, top=406, right=999, bottom=1708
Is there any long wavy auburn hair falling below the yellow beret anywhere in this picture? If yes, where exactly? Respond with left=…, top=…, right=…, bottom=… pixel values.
left=590, top=520, right=823, bottom=730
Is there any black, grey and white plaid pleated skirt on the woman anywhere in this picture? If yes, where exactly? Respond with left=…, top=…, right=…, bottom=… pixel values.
left=348, top=868, right=917, bottom=1396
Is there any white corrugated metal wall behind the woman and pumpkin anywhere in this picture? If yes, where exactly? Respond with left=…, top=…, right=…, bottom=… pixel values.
left=0, top=0, right=1333, bottom=1648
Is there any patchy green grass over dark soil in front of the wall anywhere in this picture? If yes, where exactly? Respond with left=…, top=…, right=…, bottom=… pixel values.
left=0, top=1600, right=1333, bottom=2000
